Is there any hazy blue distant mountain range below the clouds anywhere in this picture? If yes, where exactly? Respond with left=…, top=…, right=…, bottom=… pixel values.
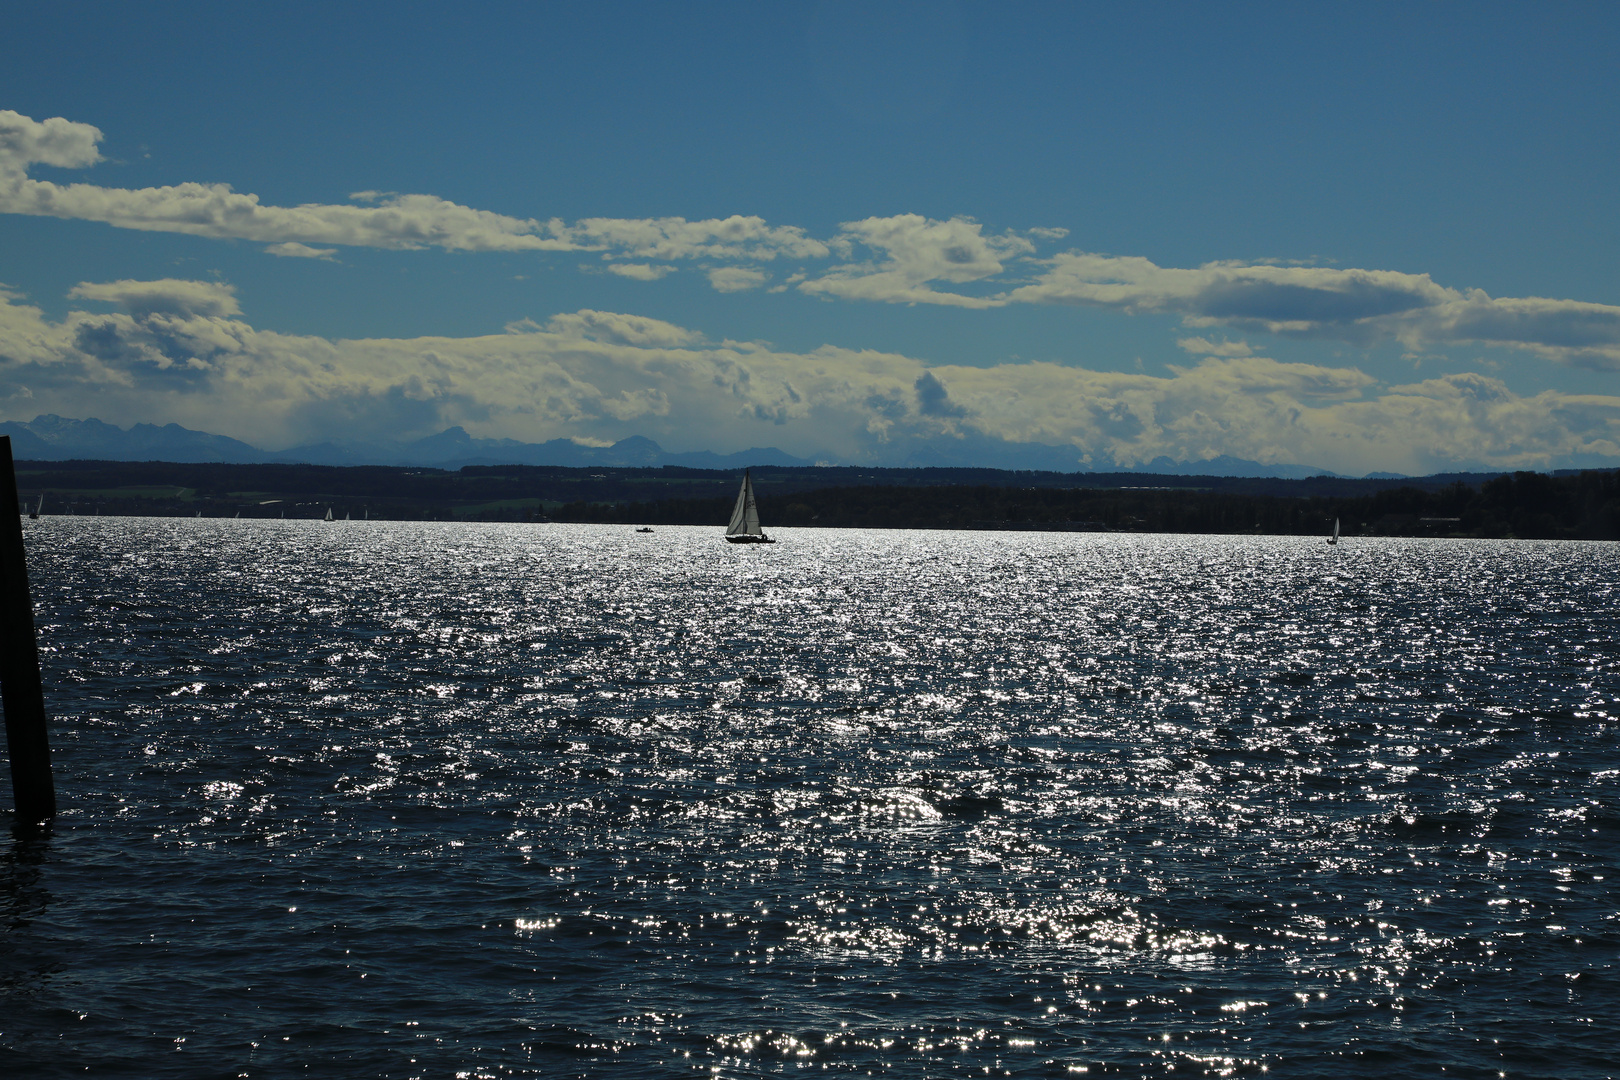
left=0, top=415, right=1354, bottom=479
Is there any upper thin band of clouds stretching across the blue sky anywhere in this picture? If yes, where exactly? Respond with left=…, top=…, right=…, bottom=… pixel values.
left=0, top=110, right=1620, bottom=371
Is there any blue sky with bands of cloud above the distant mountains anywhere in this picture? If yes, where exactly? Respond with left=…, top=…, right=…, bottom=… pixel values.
left=0, top=3, right=1620, bottom=473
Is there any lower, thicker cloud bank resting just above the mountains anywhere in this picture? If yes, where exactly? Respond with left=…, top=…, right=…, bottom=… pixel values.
left=0, top=279, right=1620, bottom=474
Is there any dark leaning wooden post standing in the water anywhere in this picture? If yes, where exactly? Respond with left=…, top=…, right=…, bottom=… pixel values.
left=0, top=436, right=57, bottom=824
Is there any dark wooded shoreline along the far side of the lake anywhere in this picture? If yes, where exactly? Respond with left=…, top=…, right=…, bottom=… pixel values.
left=18, top=461, right=1620, bottom=539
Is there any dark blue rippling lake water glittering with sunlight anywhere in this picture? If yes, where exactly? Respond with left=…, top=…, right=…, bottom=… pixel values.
left=0, top=518, right=1620, bottom=1078
